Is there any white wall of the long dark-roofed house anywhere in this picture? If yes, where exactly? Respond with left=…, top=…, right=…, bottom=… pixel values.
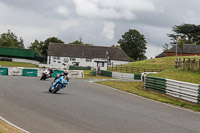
left=47, top=56, right=128, bottom=70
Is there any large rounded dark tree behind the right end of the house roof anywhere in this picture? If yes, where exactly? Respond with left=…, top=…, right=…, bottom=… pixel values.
left=118, top=29, right=147, bottom=60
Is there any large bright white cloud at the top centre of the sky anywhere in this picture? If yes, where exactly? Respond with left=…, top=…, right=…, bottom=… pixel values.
left=74, top=0, right=156, bottom=20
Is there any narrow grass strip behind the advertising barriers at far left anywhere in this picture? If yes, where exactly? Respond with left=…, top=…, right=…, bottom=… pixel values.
left=0, top=61, right=38, bottom=68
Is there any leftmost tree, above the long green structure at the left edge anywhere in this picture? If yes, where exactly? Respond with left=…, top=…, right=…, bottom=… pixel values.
left=0, top=30, right=24, bottom=48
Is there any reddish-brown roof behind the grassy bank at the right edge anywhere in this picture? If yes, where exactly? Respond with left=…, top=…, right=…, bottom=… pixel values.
left=166, top=44, right=200, bottom=54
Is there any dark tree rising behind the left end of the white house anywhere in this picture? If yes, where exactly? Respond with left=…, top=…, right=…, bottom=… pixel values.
left=40, top=37, right=64, bottom=57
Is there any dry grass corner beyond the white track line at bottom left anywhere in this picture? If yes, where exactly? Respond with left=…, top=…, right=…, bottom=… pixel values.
left=0, top=120, right=23, bottom=133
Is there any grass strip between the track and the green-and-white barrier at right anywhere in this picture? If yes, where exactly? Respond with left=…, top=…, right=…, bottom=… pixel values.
left=96, top=81, right=200, bottom=111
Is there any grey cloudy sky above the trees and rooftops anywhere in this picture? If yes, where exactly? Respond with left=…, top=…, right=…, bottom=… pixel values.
left=0, top=0, right=200, bottom=58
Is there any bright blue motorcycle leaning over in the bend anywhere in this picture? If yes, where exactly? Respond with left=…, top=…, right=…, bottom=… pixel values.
left=49, top=76, right=68, bottom=94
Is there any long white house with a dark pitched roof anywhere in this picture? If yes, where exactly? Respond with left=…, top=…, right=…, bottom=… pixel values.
left=47, top=43, right=129, bottom=70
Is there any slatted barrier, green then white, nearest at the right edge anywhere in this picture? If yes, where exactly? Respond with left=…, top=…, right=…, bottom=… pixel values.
left=145, top=76, right=200, bottom=103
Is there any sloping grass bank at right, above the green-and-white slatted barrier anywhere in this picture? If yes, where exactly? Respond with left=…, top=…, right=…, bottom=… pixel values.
left=110, top=56, right=200, bottom=84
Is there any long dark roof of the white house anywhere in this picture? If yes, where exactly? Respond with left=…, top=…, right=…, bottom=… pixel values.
left=48, top=43, right=129, bottom=61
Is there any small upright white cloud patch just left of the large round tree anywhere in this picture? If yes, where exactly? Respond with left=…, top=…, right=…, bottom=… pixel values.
left=103, top=21, right=115, bottom=40
